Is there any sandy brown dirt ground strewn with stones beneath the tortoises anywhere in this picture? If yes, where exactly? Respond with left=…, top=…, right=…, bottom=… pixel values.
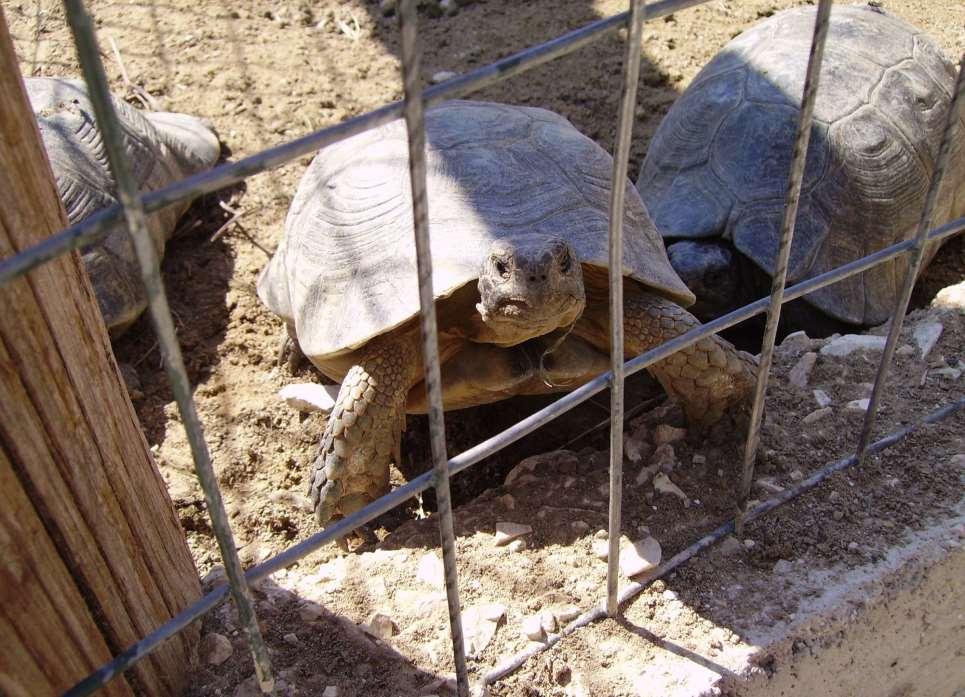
left=3, top=0, right=965, bottom=695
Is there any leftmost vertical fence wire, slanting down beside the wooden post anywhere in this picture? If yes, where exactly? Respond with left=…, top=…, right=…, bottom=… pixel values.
left=64, top=0, right=275, bottom=695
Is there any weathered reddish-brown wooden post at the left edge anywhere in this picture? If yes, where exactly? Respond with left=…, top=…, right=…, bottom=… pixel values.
left=0, top=10, right=200, bottom=697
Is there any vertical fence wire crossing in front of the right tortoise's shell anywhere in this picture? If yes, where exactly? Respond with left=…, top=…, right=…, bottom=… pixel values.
left=734, top=0, right=831, bottom=535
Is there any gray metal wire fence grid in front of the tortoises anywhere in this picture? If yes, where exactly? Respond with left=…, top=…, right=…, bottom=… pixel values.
left=0, top=0, right=965, bottom=697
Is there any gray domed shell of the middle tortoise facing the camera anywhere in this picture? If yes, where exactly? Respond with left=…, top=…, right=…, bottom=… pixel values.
left=258, top=101, right=693, bottom=359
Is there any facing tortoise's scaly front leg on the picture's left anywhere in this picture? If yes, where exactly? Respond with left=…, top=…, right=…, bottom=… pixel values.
left=310, top=333, right=422, bottom=525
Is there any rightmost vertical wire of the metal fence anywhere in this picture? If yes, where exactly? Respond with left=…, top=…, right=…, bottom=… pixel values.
left=855, top=54, right=965, bottom=464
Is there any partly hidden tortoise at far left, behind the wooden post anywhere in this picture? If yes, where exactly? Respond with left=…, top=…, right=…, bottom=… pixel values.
left=24, top=77, right=221, bottom=337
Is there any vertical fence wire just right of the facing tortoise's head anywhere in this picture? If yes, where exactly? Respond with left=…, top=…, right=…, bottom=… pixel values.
left=606, top=0, right=646, bottom=616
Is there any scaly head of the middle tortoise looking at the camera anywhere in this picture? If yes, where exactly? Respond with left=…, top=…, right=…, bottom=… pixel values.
left=476, top=235, right=586, bottom=346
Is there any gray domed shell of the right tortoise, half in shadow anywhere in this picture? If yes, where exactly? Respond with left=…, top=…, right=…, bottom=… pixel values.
left=637, top=6, right=965, bottom=324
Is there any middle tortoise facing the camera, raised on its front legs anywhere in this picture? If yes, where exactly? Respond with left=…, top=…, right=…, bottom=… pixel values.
left=258, top=101, right=756, bottom=525
